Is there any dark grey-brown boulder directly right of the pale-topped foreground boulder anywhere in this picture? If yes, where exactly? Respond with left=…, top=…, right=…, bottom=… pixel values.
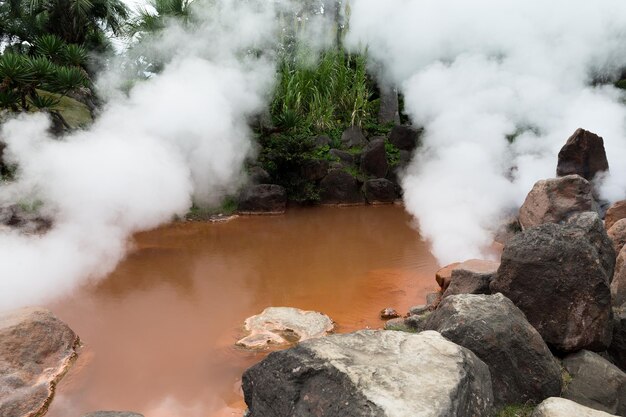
left=425, top=294, right=561, bottom=405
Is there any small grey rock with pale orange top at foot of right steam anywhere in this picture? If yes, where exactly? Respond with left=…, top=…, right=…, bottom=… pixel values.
left=443, top=259, right=500, bottom=298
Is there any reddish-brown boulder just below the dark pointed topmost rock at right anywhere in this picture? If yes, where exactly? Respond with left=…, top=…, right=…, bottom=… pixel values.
left=519, top=175, right=597, bottom=229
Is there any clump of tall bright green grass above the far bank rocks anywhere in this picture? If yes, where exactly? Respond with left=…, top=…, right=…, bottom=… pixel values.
left=271, top=49, right=374, bottom=134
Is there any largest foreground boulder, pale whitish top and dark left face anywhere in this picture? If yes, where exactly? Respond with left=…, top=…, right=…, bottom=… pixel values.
left=242, top=330, right=493, bottom=417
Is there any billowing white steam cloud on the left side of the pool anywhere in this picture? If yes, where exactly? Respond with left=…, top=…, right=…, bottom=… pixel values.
left=0, top=0, right=275, bottom=309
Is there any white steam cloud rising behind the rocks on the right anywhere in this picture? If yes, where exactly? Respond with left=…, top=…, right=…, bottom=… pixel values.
left=348, top=0, right=626, bottom=264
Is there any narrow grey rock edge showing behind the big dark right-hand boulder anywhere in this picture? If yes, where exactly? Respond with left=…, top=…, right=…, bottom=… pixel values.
left=566, top=211, right=617, bottom=281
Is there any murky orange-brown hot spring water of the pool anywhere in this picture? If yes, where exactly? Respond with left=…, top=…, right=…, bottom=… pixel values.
left=48, top=206, right=437, bottom=417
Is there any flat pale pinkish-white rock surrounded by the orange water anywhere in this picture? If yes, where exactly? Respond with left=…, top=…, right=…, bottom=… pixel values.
left=237, top=307, right=335, bottom=349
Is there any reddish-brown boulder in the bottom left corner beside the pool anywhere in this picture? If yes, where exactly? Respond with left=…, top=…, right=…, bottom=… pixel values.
left=0, top=308, right=79, bottom=417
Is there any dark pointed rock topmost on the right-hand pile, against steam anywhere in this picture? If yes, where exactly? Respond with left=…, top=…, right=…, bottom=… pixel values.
left=556, top=129, right=609, bottom=181
